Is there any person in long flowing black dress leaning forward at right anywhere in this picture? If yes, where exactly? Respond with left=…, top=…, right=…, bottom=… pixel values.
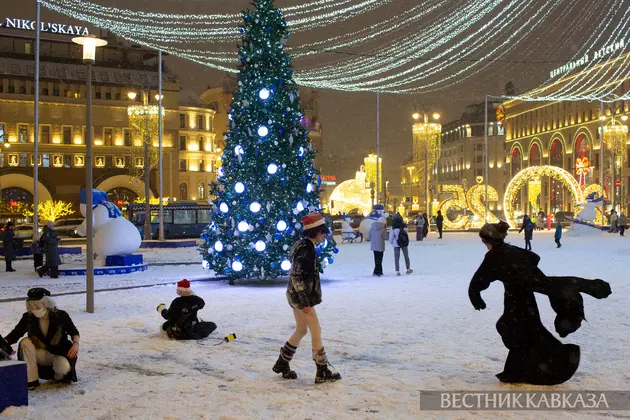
left=468, top=222, right=611, bottom=385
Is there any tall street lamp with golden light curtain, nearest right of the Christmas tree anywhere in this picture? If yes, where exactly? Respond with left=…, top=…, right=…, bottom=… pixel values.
left=411, top=111, right=442, bottom=214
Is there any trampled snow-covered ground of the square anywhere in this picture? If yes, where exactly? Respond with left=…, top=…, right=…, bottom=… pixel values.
left=0, top=232, right=630, bottom=420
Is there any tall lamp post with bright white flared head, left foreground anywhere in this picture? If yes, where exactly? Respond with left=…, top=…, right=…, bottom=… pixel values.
left=74, top=35, right=107, bottom=313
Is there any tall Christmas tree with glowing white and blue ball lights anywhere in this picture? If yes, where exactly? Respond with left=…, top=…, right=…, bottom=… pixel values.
left=200, top=0, right=337, bottom=280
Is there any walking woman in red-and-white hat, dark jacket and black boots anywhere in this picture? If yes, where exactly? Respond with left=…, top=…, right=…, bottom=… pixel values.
left=272, top=212, right=341, bottom=383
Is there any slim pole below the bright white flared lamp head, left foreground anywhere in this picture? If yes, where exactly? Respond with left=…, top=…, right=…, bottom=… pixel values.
left=85, top=62, right=94, bottom=314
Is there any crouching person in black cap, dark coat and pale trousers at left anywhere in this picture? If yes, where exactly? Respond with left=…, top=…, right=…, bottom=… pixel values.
left=5, top=287, right=80, bottom=390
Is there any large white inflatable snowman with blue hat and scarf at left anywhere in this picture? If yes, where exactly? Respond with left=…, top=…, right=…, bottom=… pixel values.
left=77, top=189, right=142, bottom=266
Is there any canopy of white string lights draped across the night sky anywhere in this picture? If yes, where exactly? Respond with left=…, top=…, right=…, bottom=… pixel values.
left=42, top=0, right=630, bottom=97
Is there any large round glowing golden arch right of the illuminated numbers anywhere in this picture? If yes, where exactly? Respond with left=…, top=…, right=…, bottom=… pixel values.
left=503, top=165, right=582, bottom=227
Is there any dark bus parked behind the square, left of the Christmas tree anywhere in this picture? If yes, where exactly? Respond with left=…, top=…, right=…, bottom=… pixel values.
left=126, top=202, right=212, bottom=239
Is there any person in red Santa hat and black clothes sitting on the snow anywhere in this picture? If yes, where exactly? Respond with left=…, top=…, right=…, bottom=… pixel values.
left=157, top=279, right=217, bottom=340
